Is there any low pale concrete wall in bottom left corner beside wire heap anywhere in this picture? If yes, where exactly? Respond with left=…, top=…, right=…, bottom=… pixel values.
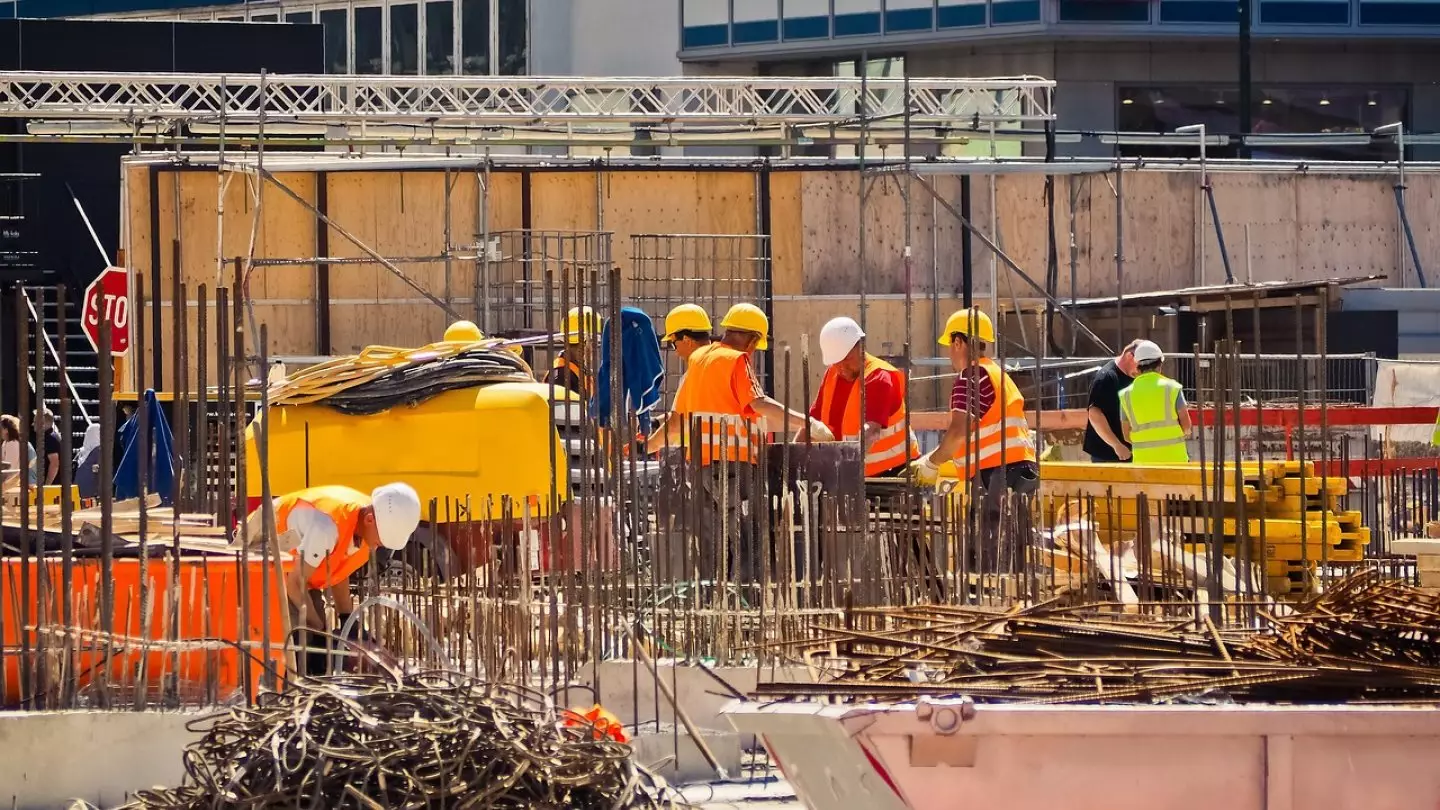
left=0, top=712, right=199, bottom=810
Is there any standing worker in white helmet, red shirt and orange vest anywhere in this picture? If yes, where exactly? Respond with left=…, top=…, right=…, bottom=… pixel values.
left=809, top=317, right=920, bottom=479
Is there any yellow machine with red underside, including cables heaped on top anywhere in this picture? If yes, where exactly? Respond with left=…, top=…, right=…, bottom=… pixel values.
left=245, top=328, right=573, bottom=569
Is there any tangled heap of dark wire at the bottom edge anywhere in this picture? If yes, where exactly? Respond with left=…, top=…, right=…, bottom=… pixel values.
left=110, top=673, right=674, bottom=810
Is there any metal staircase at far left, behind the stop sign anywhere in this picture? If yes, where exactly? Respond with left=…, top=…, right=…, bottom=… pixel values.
left=24, top=287, right=99, bottom=450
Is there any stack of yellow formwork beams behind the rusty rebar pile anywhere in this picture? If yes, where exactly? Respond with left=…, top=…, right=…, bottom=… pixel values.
left=1043, top=461, right=1371, bottom=597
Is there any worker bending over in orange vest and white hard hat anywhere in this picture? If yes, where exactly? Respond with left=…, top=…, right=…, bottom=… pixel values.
left=248, top=483, right=420, bottom=675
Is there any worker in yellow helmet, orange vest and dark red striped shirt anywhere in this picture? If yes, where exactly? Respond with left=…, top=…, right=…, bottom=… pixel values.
left=910, top=307, right=1040, bottom=571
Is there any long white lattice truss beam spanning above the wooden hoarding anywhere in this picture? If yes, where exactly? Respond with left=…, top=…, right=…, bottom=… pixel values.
left=0, top=72, right=1054, bottom=134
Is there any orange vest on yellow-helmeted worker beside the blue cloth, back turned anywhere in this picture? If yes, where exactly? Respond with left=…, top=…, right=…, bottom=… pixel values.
left=675, top=343, right=762, bottom=466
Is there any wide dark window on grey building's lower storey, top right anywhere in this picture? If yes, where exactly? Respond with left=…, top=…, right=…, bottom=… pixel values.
left=1116, top=85, right=1410, bottom=160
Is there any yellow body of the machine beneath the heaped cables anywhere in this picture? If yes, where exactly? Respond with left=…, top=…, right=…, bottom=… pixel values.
left=245, top=382, right=569, bottom=522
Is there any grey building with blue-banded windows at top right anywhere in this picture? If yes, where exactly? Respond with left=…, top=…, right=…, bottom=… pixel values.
left=677, top=0, right=1440, bottom=159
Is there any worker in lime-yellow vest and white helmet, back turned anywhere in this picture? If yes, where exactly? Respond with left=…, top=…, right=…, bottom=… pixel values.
left=1120, top=340, right=1191, bottom=464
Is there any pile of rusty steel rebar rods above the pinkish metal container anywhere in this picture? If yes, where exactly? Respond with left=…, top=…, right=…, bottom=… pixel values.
left=756, top=572, right=1440, bottom=703
